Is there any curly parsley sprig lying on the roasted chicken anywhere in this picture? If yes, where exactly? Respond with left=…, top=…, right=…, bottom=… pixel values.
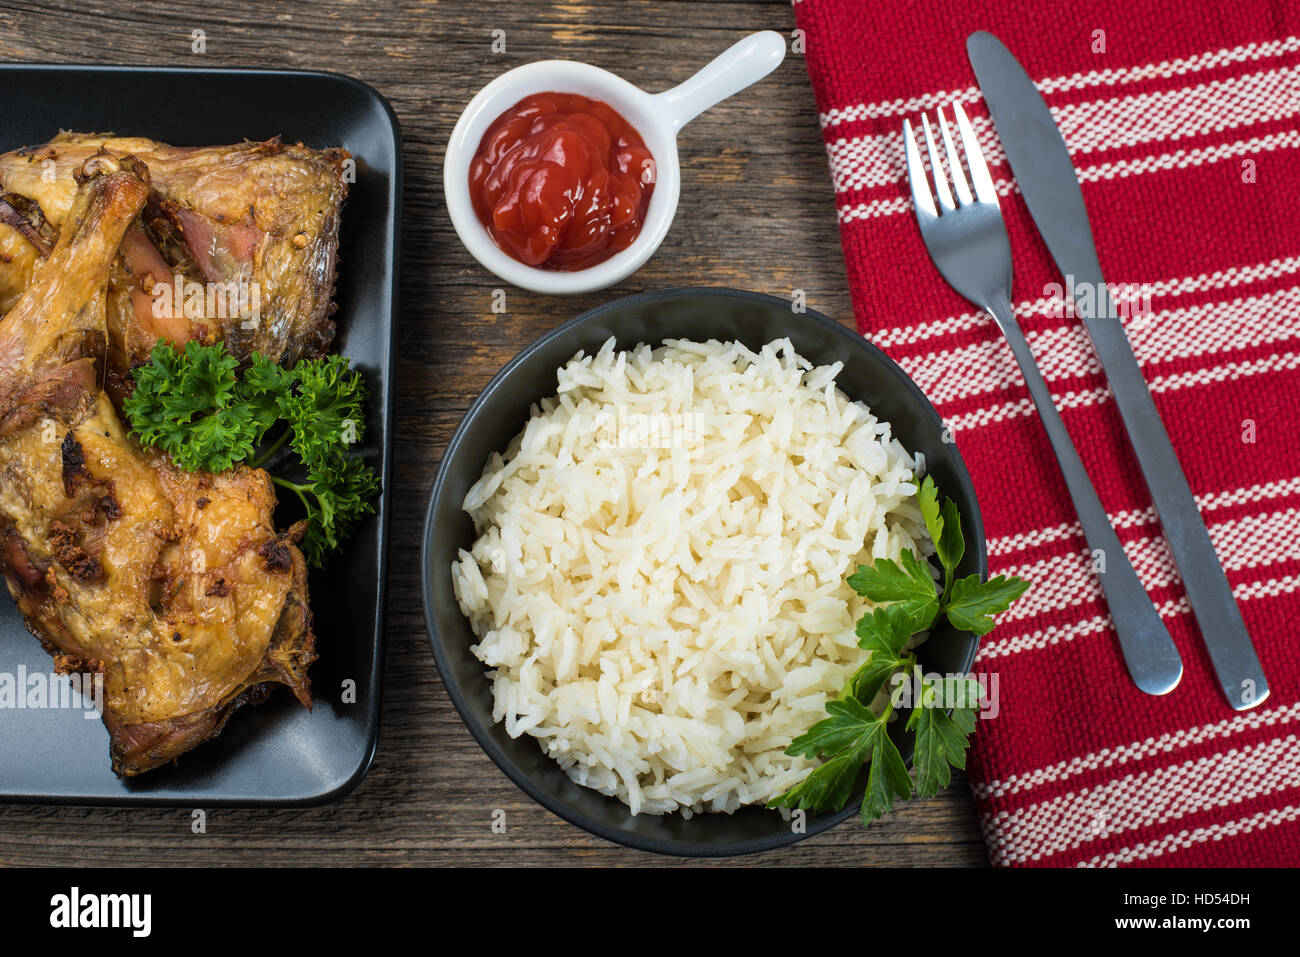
left=122, top=339, right=378, bottom=568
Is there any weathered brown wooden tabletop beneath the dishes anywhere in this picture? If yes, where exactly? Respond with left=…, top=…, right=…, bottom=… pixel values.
left=0, top=0, right=988, bottom=866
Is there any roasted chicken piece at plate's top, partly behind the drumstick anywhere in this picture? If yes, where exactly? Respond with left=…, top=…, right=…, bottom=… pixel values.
left=0, top=133, right=350, bottom=372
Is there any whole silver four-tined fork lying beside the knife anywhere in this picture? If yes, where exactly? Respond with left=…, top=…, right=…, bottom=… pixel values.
left=902, top=101, right=1183, bottom=694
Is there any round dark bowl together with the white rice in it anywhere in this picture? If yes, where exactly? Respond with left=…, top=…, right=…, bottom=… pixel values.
left=421, top=289, right=988, bottom=856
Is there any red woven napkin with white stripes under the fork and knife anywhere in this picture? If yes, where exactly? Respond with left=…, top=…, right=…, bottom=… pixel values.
left=794, top=0, right=1300, bottom=866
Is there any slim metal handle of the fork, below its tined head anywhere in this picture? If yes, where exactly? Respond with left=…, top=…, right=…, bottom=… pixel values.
left=984, top=291, right=1183, bottom=694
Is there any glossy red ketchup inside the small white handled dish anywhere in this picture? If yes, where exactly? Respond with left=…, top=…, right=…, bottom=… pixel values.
left=469, top=92, right=655, bottom=272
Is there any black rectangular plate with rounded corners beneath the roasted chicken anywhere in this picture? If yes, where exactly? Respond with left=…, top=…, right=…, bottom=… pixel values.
left=0, top=65, right=402, bottom=805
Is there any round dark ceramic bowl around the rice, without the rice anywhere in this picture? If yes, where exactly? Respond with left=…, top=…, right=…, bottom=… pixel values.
left=421, top=289, right=988, bottom=857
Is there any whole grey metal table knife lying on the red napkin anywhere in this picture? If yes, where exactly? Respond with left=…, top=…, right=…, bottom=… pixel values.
left=966, top=31, right=1269, bottom=711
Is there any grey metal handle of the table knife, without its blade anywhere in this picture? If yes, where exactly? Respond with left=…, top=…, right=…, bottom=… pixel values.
left=1076, top=283, right=1269, bottom=711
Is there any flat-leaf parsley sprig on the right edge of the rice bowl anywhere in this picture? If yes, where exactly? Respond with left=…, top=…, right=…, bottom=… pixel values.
left=768, top=476, right=1030, bottom=824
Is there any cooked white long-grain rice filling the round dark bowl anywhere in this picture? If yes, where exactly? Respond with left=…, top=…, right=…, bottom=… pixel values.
left=451, top=339, right=932, bottom=817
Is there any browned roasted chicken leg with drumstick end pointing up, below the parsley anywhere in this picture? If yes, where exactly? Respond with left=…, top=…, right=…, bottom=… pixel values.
left=0, top=153, right=316, bottom=776
